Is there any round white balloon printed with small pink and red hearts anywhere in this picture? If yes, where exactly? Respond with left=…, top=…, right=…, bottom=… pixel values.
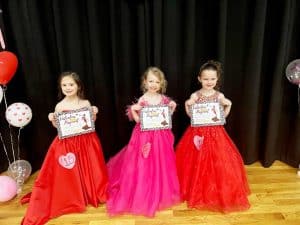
left=5, top=102, right=32, bottom=127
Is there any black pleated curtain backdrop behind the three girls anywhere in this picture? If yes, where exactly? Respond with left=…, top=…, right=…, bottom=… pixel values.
left=0, top=0, right=300, bottom=171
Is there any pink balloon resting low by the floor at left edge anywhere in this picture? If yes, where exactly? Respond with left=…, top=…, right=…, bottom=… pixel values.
left=0, top=176, right=17, bottom=202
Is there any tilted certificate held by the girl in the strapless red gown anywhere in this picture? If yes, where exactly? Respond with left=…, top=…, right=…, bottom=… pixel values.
left=56, top=107, right=95, bottom=139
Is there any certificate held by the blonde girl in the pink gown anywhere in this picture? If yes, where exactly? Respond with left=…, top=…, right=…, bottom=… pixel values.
left=140, top=106, right=172, bottom=131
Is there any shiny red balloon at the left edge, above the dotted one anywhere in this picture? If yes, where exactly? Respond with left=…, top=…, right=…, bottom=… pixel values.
left=0, top=51, right=18, bottom=85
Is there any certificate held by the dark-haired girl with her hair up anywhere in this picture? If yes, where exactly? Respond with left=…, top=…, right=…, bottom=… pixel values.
left=190, top=102, right=226, bottom=127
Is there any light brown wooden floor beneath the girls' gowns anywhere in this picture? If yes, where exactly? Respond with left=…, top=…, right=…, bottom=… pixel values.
left=0, top=161, right=300, bottom=225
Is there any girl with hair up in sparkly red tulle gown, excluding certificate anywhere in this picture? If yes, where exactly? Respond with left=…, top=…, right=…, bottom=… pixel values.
left=175, top=61, right=250, bottom=212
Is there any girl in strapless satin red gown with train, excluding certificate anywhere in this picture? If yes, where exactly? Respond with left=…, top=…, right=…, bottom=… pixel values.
left=22, top=72, right=108, bottom=225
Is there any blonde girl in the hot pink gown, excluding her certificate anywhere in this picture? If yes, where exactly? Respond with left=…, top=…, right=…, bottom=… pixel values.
left=107, top=67, right=180, bottom=217
